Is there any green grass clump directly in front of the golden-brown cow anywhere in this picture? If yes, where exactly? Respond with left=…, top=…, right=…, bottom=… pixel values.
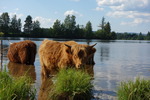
left=50, top=68, right=93, bottom=100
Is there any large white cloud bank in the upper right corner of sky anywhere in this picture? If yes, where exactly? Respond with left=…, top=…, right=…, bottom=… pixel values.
left=96, top=0, right=150, bottom=26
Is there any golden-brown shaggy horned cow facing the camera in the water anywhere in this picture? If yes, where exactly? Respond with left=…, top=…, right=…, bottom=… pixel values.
left=39, top=39, right=96, bottom=76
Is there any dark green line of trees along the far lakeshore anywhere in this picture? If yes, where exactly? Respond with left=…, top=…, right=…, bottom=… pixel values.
left=0, top=12, right=150, bottom=40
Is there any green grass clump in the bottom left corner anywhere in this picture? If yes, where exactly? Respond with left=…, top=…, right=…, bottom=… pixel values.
left=0, top=71, right=36, bottom=100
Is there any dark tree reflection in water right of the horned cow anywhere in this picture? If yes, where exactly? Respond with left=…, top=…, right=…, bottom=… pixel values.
left=100, top=46, right=109, bottom=62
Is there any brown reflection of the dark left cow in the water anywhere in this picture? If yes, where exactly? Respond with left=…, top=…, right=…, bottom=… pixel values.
left=7, top=62, right=36, bottom=82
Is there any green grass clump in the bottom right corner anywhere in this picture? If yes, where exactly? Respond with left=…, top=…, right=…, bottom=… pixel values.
left=117, top=78, right=150, bottom=100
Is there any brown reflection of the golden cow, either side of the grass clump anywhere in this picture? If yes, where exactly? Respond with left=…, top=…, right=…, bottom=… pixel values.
left=38, top=65, right=94, bottom=100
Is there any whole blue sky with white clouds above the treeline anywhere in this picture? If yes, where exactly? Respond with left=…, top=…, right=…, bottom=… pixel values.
left=0, top=0, right=150, bottom=34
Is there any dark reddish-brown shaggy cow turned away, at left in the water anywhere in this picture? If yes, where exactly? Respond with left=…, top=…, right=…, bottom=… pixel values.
left=7, top=40, right=36, bottom=65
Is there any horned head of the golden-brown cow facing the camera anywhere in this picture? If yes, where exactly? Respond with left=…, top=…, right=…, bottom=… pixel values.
left=65, top=44, right=96, bottom=68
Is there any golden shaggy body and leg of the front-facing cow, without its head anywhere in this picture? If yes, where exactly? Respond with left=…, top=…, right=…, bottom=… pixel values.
left=39, top=39, right=72, bottom=76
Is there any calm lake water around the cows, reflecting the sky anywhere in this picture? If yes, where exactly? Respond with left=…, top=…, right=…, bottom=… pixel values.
left=0, top=38, right=150, bottom=100
